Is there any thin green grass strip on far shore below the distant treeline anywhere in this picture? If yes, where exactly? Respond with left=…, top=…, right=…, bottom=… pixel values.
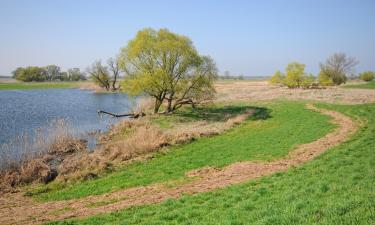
left=0, top=81, right=82, bottom=90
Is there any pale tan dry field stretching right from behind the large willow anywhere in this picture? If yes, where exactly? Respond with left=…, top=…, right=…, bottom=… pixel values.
left=216, top=81, right=375, bottom=104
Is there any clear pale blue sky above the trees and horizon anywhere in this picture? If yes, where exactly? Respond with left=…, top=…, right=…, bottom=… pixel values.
left=0, top=0, right=375, bottom=76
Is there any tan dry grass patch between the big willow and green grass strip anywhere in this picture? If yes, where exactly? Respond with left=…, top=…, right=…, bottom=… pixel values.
left=52, top=110, right=254, bottom=182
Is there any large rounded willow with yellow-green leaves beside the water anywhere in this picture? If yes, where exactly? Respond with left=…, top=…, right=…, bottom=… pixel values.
left=120, top=29, right=217, bottom=113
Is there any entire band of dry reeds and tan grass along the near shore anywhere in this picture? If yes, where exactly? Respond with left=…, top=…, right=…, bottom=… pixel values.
left=0, top=100, right=256, bottom=192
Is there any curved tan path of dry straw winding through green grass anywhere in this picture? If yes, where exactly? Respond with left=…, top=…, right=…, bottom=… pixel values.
left=0, top=105, right=357, bottom=224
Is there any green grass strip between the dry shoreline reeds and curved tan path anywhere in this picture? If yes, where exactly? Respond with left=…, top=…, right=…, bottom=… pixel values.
left=30, top=102, right=333, bottom=201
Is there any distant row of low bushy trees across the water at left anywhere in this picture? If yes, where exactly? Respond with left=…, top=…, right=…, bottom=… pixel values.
left=12, top=65, right=87, bottom=82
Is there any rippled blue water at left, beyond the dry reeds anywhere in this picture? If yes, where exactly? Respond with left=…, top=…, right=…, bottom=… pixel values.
left=0, top=89, right=132, bottom=152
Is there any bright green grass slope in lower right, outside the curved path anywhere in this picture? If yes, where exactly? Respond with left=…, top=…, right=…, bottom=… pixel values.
left=47, top=104, right=375, bottom=225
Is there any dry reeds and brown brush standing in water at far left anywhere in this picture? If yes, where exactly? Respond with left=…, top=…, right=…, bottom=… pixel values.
left=0, top=119, right=86, bottom=193
